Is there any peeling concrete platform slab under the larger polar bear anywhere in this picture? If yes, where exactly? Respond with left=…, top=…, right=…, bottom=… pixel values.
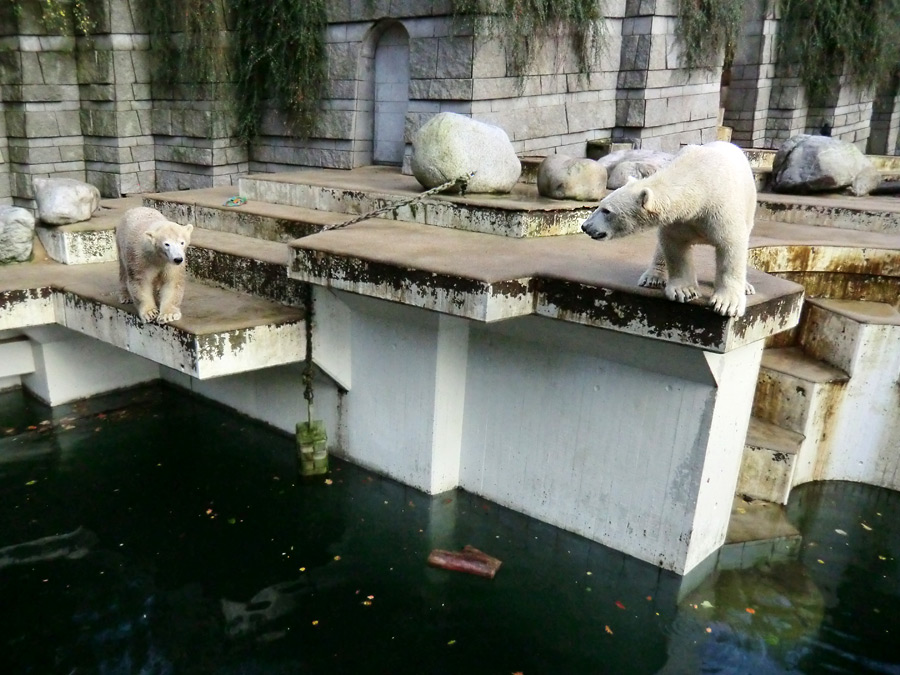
left=289, top=220, right=803, bottom=352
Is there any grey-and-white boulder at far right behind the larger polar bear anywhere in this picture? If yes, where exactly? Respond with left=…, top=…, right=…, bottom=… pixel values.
left=772, top=134, right=881, bottom=197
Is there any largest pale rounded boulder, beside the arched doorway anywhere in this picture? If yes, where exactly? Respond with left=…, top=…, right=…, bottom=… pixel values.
left=411, top=113, right=522, bottom=193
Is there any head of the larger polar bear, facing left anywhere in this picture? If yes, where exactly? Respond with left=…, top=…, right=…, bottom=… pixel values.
left=581, top=178, right=659, bottom=241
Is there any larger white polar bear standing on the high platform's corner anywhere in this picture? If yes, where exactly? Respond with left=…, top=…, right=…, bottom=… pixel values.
left=581, top=141, right=756, bottom=316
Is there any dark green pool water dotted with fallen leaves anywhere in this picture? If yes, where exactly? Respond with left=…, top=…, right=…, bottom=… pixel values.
left=0, top=387, right=900, bottom=675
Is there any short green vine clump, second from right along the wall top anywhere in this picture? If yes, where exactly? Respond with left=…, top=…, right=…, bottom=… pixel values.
left=675, top=0, right=744, bottom=70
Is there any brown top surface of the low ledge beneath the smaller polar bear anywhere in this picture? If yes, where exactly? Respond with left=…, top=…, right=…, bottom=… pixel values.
left=0, top=262, right=304, bottom=336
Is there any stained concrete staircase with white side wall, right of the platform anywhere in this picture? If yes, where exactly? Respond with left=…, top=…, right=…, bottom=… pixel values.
left=737, top=286, right=900, bottom=504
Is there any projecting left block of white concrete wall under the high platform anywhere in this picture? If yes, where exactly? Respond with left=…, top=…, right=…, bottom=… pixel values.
left=339, top=294, right=469, bottom=494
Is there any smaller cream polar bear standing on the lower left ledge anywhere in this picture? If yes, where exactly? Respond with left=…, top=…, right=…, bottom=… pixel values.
left=116, top=206, right=194, bottom=323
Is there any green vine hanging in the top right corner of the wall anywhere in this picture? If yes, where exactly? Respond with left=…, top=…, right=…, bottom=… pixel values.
left=778, top=0, right=900, bottom=101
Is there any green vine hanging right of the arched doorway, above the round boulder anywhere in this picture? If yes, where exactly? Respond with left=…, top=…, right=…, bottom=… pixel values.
left=453, top=0, right=605, bottom=75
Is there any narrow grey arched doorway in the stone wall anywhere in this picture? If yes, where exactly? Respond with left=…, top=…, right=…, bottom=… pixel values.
left=372, top=23, right=409, bottom=165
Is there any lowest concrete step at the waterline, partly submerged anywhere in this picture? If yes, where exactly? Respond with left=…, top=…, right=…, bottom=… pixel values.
left=716, top=497, right=803, bottom=570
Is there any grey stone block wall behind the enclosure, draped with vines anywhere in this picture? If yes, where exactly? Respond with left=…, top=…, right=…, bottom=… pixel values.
left=0, top=0, right=900, bottom=207
